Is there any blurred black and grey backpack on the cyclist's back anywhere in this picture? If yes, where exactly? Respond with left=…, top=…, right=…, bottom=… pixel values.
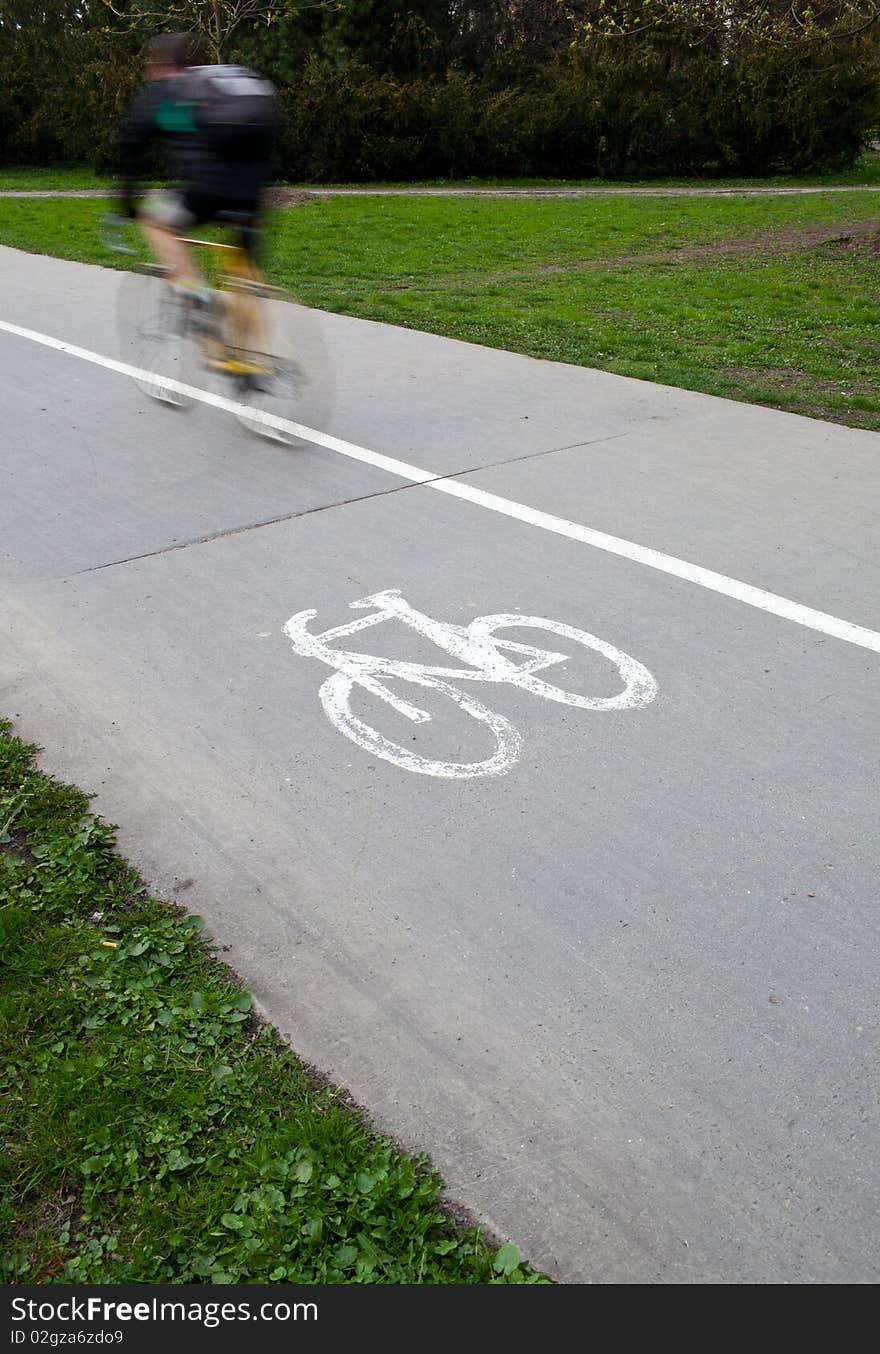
left=187, top=66, right=282, bottom=160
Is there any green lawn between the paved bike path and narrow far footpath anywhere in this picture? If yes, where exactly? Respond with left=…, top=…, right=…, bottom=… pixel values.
left=0, top=192, right=880, bottom=429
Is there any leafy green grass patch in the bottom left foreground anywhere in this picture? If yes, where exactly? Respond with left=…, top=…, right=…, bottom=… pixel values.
left=0, top=722, right=546, bottom=1284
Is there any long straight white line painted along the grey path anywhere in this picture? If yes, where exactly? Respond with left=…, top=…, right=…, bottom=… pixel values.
left=0, top=320, right=880, bottom=654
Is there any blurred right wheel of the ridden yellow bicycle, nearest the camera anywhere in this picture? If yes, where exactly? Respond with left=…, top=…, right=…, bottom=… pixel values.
left=213, top=287, right=333, bottom=445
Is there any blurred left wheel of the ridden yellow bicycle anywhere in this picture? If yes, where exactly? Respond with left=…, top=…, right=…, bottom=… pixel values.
left=116, top=265, right=198, bottom=409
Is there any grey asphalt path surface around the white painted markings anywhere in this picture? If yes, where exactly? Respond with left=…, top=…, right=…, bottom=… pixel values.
left=0, top=249, right=880, bottom=1284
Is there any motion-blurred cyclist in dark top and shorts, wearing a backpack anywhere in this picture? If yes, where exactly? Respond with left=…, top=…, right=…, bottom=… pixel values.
left=120, top=32, right=279, bottom=298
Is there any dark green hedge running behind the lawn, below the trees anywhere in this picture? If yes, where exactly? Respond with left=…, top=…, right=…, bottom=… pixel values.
left=0, top=30, right=879, bottom=183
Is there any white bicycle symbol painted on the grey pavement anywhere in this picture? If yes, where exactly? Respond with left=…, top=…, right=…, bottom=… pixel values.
left=284, top=588, right=657, bottom=779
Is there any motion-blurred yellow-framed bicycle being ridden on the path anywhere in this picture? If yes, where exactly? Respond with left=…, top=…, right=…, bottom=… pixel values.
left=103, top=213, right=330, bottom=444
